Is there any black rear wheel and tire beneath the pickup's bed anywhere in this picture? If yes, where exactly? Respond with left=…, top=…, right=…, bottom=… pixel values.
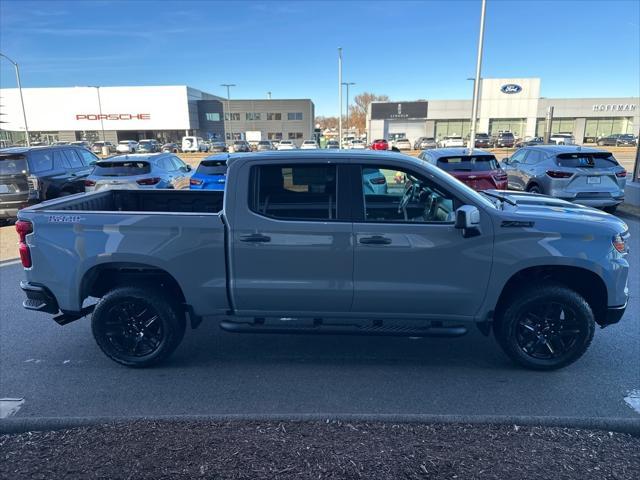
left=91, top=287, right=186, bottom=368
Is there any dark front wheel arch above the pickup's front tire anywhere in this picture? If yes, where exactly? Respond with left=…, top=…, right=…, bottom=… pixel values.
left=493, top=265, right=608, bottom=326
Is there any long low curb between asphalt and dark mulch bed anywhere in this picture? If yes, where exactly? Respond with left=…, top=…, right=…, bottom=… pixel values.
left=0, top=413, right=640, bottom=437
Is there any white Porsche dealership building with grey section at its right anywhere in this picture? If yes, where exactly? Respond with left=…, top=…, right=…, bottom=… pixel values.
left=0, top=85, right=315, bottom=144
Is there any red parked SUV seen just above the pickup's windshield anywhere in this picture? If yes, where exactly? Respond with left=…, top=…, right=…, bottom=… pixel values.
left=418, top=148, right=507, bottom=191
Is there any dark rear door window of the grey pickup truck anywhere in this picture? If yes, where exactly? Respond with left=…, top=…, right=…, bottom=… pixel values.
left=249, top=164, right=337, bottom=220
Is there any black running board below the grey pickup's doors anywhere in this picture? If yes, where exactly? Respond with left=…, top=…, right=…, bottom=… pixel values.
left=220, top=319, right=468, bottom=337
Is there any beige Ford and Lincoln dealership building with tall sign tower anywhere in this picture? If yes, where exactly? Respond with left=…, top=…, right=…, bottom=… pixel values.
left=367, top=78, right=640, bottom=143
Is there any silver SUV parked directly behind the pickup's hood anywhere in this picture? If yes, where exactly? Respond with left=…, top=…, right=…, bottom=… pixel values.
left=503, top=145, right=627, bottom=213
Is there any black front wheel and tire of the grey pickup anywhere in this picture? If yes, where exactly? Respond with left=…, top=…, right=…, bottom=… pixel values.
left=494, top=284, right=595, bottom=370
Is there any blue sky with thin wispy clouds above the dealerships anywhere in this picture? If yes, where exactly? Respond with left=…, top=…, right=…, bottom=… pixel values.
left=0, top=0, right=640, bottom=116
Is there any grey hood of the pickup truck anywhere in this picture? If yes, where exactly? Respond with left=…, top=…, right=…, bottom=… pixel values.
left=489, top=190, right=628, bottom=233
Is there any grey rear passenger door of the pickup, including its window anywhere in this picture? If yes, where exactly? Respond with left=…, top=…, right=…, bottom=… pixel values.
left=231, top=160, right=353, bottom=317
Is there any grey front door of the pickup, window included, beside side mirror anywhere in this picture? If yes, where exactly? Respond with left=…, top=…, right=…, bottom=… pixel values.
left=352, top=164, right=493, bottom=320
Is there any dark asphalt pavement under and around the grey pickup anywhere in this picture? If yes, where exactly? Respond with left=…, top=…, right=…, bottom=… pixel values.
left=0, top=212, right=640, bottom=418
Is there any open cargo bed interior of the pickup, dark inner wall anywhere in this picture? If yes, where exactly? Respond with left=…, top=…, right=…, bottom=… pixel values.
left=30, top=190, right=224, bottom=213
